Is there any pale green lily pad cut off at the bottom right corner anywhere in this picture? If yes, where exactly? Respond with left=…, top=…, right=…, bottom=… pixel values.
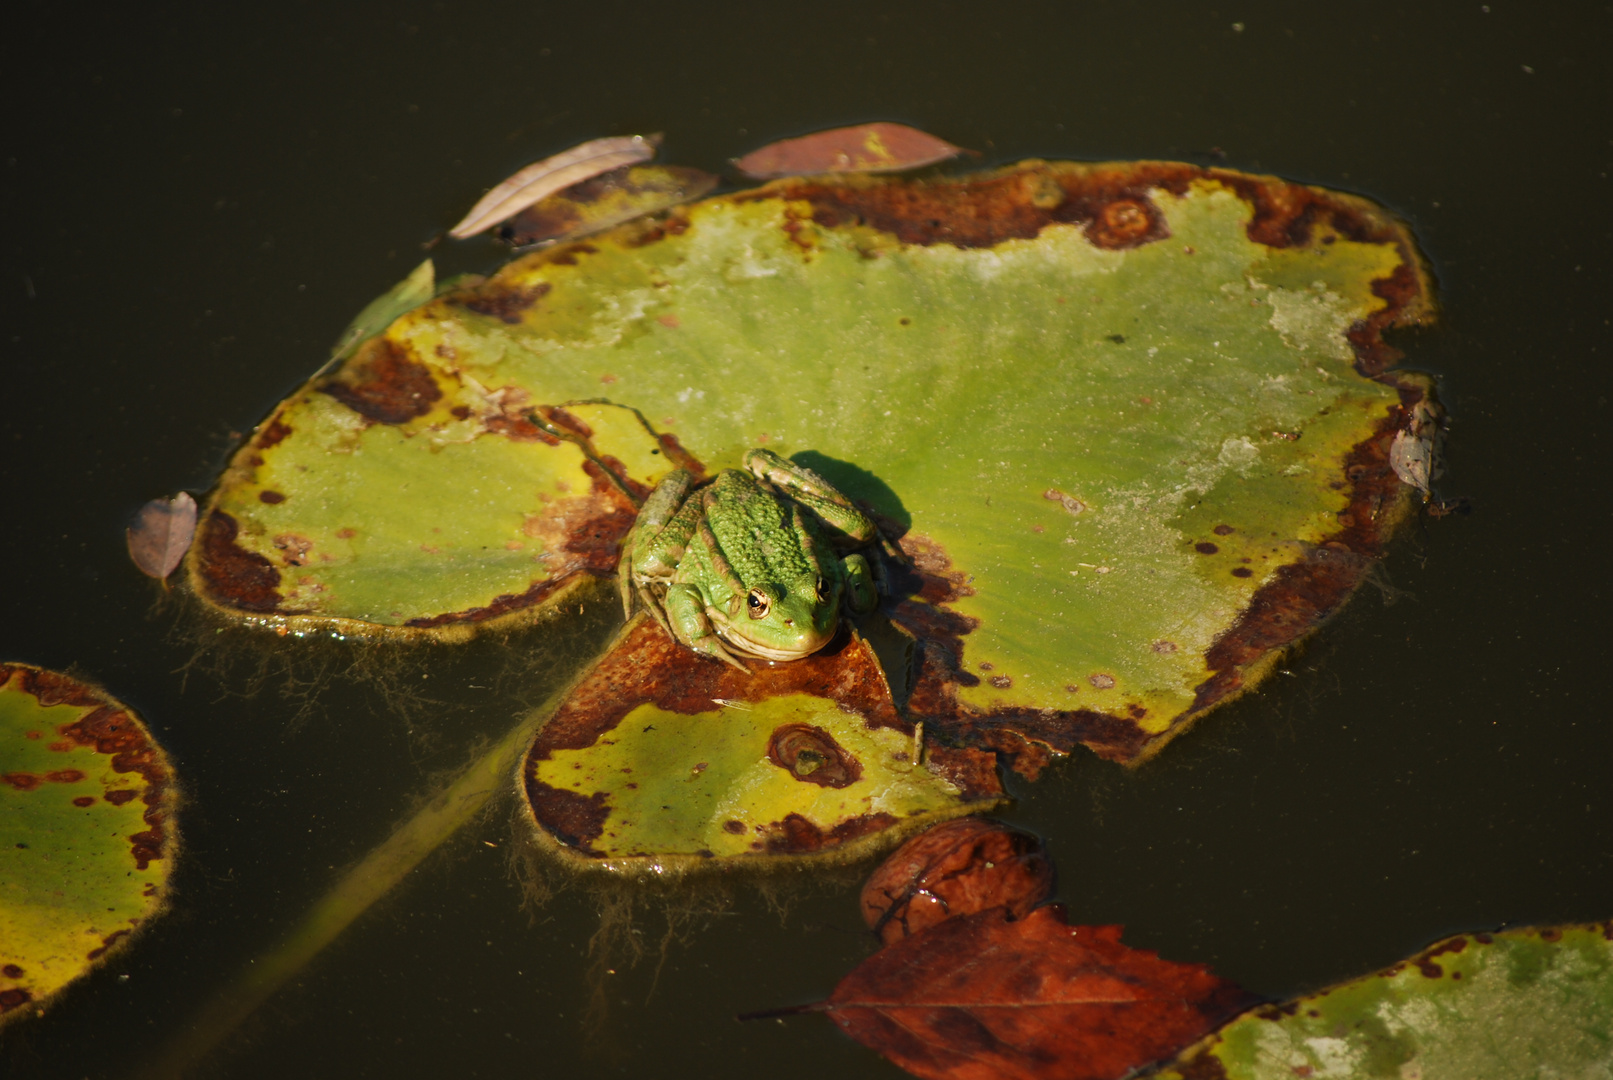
left=1157, top=922, right=1613, bottom=1080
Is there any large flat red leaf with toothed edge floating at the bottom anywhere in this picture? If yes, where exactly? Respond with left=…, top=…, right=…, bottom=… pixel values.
left=826, top=904, right=1253, bottom=1080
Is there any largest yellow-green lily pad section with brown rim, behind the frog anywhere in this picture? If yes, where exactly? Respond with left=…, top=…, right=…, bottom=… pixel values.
left=189, top=161, right=1432, bottom=775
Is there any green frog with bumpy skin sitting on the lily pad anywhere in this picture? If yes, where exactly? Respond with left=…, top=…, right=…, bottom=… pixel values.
left=618, top=448, right=895, bottom=671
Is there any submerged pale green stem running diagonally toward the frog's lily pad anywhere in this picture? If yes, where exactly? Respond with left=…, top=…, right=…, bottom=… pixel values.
left=140, top=700, right=555, bottom=1078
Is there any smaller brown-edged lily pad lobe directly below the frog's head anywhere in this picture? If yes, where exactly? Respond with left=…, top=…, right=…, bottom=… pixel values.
left=519, top=614, right=1002, bottom=874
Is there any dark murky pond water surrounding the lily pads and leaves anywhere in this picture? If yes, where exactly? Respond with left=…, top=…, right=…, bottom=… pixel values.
left=0, top=0, right=1613, bottom=1077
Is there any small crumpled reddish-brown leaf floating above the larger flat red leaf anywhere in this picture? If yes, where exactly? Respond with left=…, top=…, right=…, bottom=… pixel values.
left=861, top=817, right=1053, bottom=945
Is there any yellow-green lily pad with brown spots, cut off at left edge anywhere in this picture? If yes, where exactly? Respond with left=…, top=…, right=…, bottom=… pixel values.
left=0, top=664, right=177, bottom=1024
